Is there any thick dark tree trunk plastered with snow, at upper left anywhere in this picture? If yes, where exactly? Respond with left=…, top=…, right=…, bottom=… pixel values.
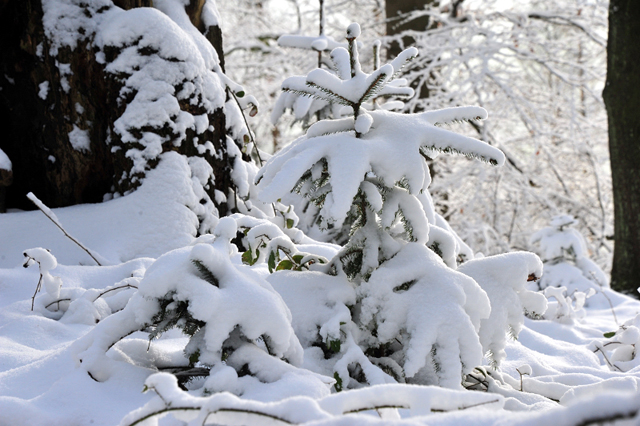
left=0, top=0, right=248, bottom=221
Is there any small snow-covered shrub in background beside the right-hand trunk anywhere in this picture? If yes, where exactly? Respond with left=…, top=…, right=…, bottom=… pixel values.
left=531, top=215, right=609, bottom=293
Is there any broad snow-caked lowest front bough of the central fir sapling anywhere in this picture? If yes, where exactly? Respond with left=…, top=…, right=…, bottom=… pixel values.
left=358, top=243, right=490, bottom=388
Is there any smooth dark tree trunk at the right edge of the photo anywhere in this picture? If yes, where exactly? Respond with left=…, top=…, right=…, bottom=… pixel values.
left=603, top=0, right=640, bottom=297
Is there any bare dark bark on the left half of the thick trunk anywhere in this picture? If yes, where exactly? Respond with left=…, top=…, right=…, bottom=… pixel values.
left=0, top=0, right=117, bottom=209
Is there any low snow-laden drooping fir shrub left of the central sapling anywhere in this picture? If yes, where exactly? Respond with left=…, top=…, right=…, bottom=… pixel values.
left=75, top=218, right=302, bottom=389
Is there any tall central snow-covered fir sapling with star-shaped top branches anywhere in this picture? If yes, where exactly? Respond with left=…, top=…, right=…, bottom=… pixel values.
left=257, top=24, right=516, bottom=389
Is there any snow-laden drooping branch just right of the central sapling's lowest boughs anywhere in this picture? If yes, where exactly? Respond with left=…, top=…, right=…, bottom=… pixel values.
left=458, top=252, right=547, bottom=366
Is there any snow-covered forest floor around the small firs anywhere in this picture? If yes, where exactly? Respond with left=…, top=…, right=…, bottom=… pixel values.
left=0, top=168, right=640, bottom=426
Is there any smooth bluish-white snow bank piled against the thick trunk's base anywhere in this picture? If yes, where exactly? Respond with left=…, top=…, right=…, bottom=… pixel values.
left=0, top=152, right=201, bottom=267
